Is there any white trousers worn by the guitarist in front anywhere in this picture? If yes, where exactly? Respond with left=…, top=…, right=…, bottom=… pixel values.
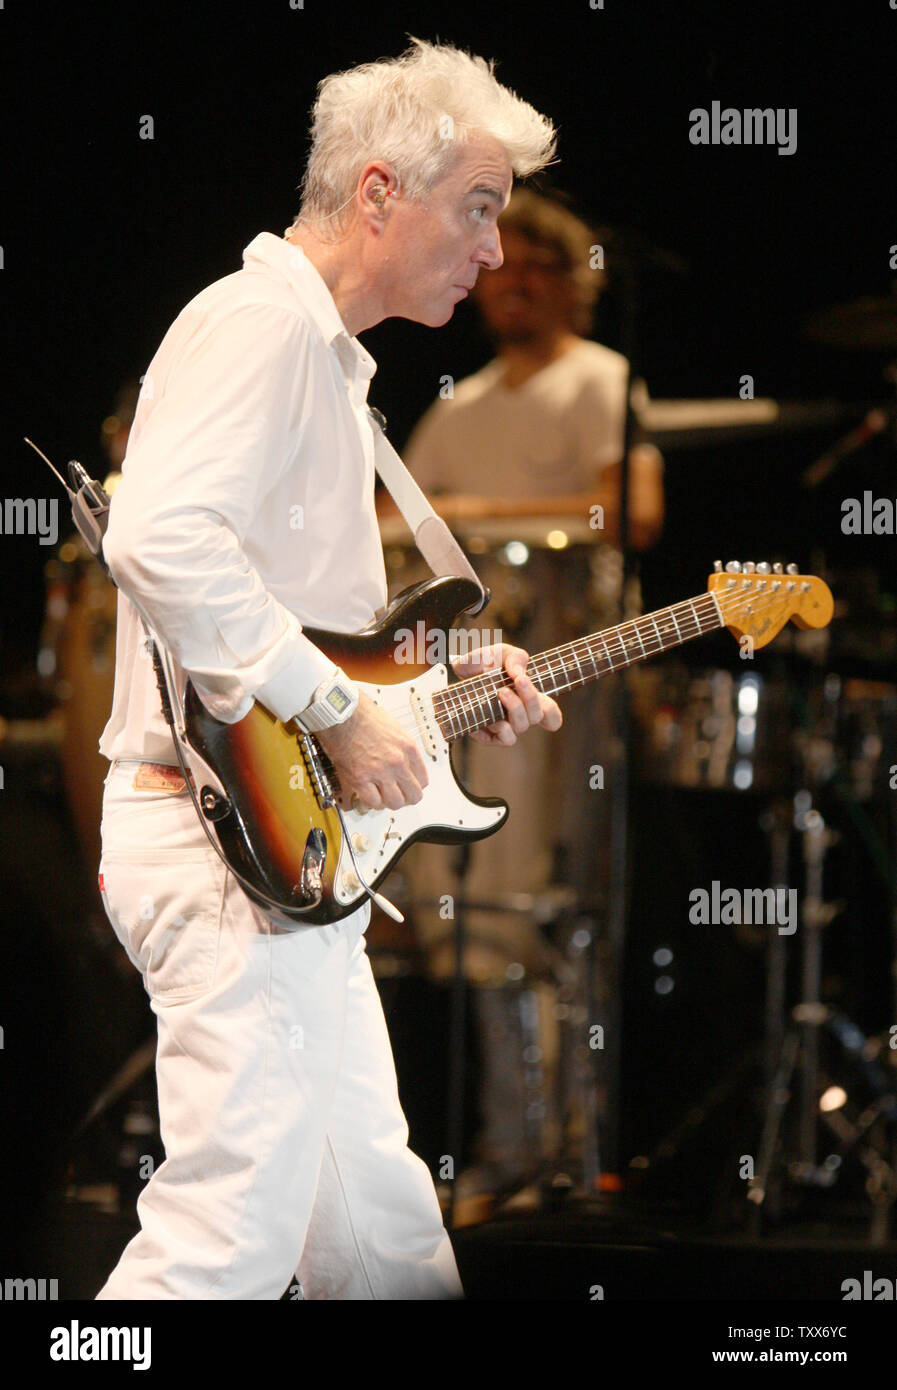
left=97, top=762, right=462, bottom=1300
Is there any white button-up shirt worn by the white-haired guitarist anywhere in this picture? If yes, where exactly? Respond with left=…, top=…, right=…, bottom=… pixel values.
left=99, top=232, right=387, bottom=763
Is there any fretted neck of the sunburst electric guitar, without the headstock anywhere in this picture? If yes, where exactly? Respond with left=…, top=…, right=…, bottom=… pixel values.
left=434, top=594, right=725, bottom=741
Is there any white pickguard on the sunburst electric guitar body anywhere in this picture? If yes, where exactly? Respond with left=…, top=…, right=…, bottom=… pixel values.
left=335, top=666, right=508, bottom=905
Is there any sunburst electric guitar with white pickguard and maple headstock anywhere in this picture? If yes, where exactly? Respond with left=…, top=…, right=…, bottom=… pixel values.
left=181, top=562, right=833, bottom=924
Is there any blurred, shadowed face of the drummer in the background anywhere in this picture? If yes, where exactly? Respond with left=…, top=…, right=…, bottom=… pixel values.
left=476, top=229, right=573, bottom=343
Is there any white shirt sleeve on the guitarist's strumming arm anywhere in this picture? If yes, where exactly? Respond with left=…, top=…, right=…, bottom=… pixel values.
left=103, top=303, right=334, bottom=723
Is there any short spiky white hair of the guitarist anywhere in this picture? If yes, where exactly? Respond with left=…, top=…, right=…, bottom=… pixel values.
left=293, top=35, right=556, bottom=231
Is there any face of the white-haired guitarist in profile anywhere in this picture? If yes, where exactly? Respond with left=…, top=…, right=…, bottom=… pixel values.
left=380, top=136, right=513, bottom=328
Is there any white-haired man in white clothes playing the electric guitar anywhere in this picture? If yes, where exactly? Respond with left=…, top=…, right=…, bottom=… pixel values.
left=99, top=39, right=560, bottom=1300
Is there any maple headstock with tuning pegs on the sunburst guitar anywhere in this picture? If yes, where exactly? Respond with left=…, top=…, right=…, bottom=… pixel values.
left=706, top=560, right=834, bottom=648
